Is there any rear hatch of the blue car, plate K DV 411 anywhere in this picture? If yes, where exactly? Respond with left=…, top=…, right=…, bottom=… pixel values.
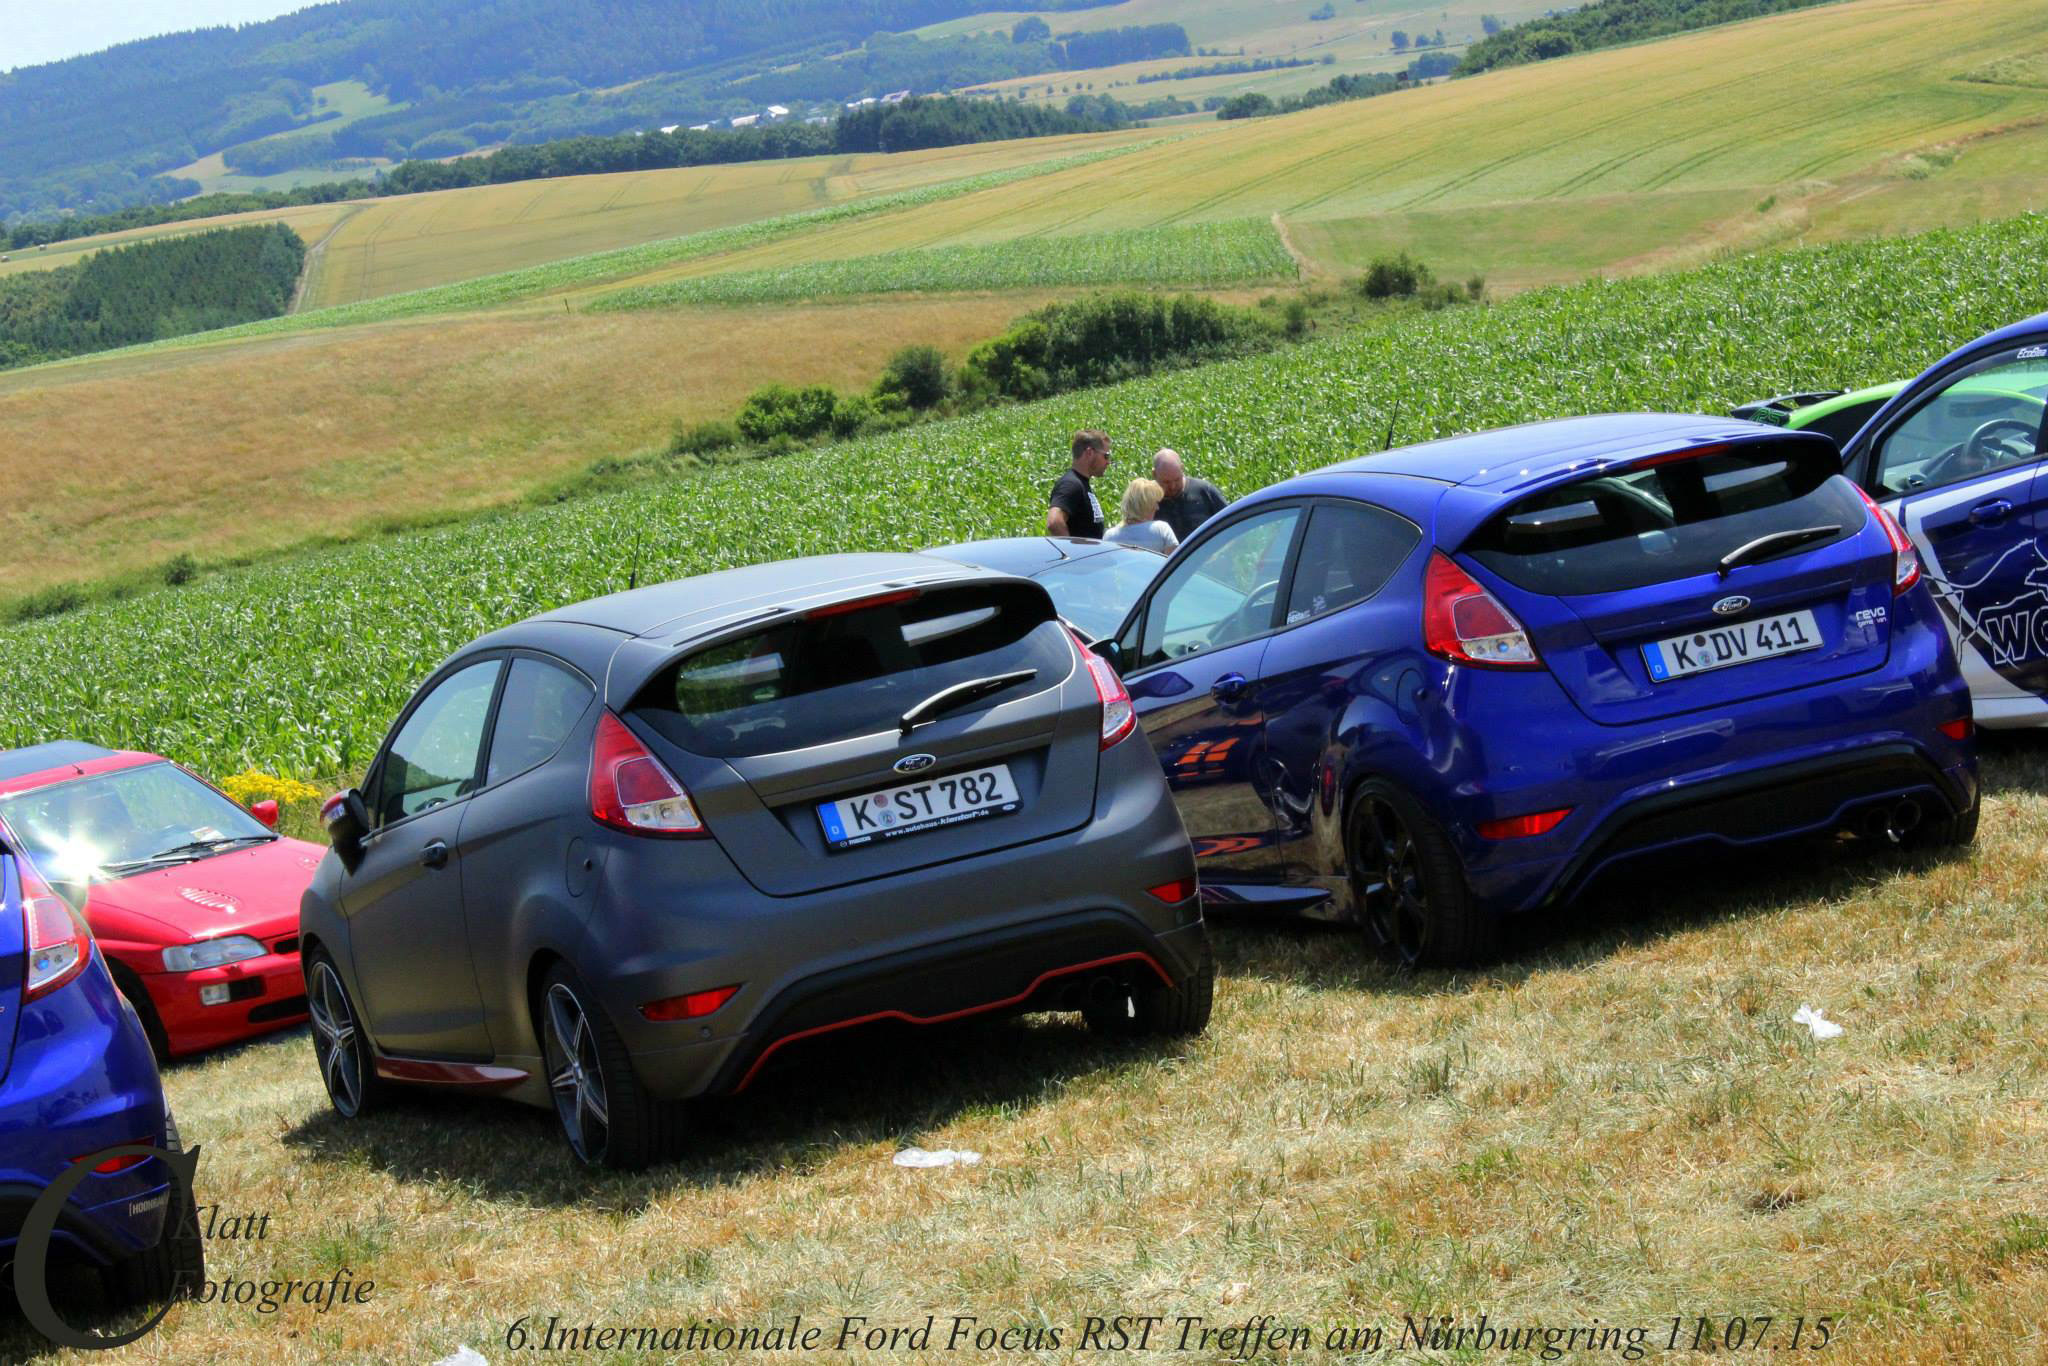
left=1462, top=436, right=1892, bottom=725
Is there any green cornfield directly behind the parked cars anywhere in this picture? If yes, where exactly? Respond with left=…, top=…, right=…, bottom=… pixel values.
left=0, top=217, right=2048, bottom=780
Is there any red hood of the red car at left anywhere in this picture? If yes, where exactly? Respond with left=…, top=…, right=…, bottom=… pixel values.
left=86, top=838, right=326, bottom=944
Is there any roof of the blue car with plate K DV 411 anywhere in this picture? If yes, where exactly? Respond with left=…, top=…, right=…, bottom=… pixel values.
left=1317, top=414, right=1772, bottom=494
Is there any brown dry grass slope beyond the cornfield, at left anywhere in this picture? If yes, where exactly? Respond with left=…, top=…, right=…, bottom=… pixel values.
left=0, top=293, right=1047, bottom=592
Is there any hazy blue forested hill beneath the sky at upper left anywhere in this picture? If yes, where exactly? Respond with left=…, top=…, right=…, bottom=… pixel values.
left=0, top=0, right=1110, bottom=217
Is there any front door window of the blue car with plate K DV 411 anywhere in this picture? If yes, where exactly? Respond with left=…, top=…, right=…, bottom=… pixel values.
left=1139, top=508, right=1300, bottom=668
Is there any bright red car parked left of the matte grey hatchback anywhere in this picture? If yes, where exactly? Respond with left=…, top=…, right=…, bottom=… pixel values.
left=0, top=741, right=326, bottom=1061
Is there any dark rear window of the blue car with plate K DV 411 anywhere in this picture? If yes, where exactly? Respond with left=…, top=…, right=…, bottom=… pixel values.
left=1464, top=440, right=1868, bottom=594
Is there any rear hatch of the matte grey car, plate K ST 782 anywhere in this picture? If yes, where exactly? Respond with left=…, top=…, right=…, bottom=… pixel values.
left=627, top=580, right=1100, bottom=897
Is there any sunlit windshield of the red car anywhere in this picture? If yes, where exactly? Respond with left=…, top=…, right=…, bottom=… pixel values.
left=0, top=762, right=276, bottom=881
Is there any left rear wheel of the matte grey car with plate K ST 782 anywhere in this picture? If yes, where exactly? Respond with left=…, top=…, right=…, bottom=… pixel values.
left=535, top=963, right=684, bottom=1171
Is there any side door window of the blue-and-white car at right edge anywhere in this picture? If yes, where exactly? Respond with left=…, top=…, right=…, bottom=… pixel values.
left=1876, top=346, right=2048, bottom=494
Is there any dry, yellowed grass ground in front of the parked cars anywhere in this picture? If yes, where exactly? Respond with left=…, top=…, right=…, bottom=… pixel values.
left=16, top=739, right=2048, bottom=1366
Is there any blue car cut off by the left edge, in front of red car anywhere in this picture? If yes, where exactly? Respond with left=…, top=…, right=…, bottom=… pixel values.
left=0, top=848, right=203, bottom=1305
